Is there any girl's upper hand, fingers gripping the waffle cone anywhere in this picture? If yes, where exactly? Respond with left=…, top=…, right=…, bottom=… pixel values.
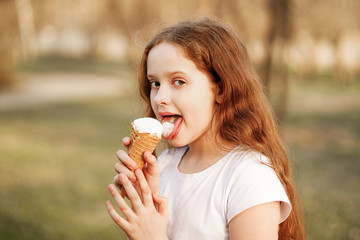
left=114, top=137, right=160, bottom=197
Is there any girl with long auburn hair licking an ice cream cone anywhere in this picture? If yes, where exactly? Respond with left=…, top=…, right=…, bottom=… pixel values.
left=107, top=19, right=306, bottom=240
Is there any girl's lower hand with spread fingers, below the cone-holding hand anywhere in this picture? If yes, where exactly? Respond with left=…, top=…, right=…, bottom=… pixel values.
left=106, top=169, right=168, bottom=240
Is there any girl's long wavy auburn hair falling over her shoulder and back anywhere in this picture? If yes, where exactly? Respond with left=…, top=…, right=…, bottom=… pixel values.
left=138, top=18, right=306, bottom=240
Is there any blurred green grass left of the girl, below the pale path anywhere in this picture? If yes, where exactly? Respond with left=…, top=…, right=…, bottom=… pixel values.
left=0, top=98, right=142, bottom=239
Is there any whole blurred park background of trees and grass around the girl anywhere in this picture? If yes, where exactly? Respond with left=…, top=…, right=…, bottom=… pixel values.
left=0, top=0, right=360, bottom=240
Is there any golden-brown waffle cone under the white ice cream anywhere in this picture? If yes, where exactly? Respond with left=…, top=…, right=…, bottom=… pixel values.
left=129, top=126, right=161, bottom=169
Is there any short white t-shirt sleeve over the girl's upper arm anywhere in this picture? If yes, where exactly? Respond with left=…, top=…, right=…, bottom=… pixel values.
left=226, top=159, right=291, bottom=223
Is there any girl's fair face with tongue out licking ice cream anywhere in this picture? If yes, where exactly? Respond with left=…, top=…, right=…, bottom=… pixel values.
left=147, top=42, right=217, bottom=147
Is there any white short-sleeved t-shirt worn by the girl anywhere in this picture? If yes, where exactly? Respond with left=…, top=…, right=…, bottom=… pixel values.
left=158, top=147, right=291, bottom=240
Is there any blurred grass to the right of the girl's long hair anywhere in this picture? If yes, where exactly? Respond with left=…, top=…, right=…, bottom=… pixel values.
left=283, top=79, right=360, bottom=240
